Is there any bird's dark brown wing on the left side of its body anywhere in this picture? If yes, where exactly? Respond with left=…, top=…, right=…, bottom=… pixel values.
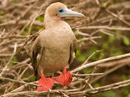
left=31, top=36, right=43, bottom=77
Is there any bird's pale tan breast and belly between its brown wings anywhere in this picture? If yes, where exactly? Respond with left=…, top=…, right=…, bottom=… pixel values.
left=40, top=23, right=73, bottom=72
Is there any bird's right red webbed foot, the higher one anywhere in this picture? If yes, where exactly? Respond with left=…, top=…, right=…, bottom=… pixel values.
left=55, top=68, right=72, bottom=86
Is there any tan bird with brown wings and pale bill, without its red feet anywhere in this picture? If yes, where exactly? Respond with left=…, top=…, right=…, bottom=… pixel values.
left=31, top=2, right=84, bottom=91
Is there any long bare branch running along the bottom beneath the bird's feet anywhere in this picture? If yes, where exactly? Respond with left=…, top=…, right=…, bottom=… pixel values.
left=1, top=79, right=130, bottom=97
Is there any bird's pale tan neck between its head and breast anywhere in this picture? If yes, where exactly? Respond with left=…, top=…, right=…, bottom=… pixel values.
left=44, top=15, right=63, bottom=29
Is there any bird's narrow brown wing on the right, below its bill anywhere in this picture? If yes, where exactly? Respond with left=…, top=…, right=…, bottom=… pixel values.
left=68, top=36, right=77, bottom=64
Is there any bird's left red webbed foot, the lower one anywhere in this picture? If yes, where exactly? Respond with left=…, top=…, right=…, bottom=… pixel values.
left=37, top=72, right=55, bottom=91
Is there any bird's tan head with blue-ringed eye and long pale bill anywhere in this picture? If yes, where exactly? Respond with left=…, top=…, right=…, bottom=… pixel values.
left=46, top=2, right=84, bottom=18
